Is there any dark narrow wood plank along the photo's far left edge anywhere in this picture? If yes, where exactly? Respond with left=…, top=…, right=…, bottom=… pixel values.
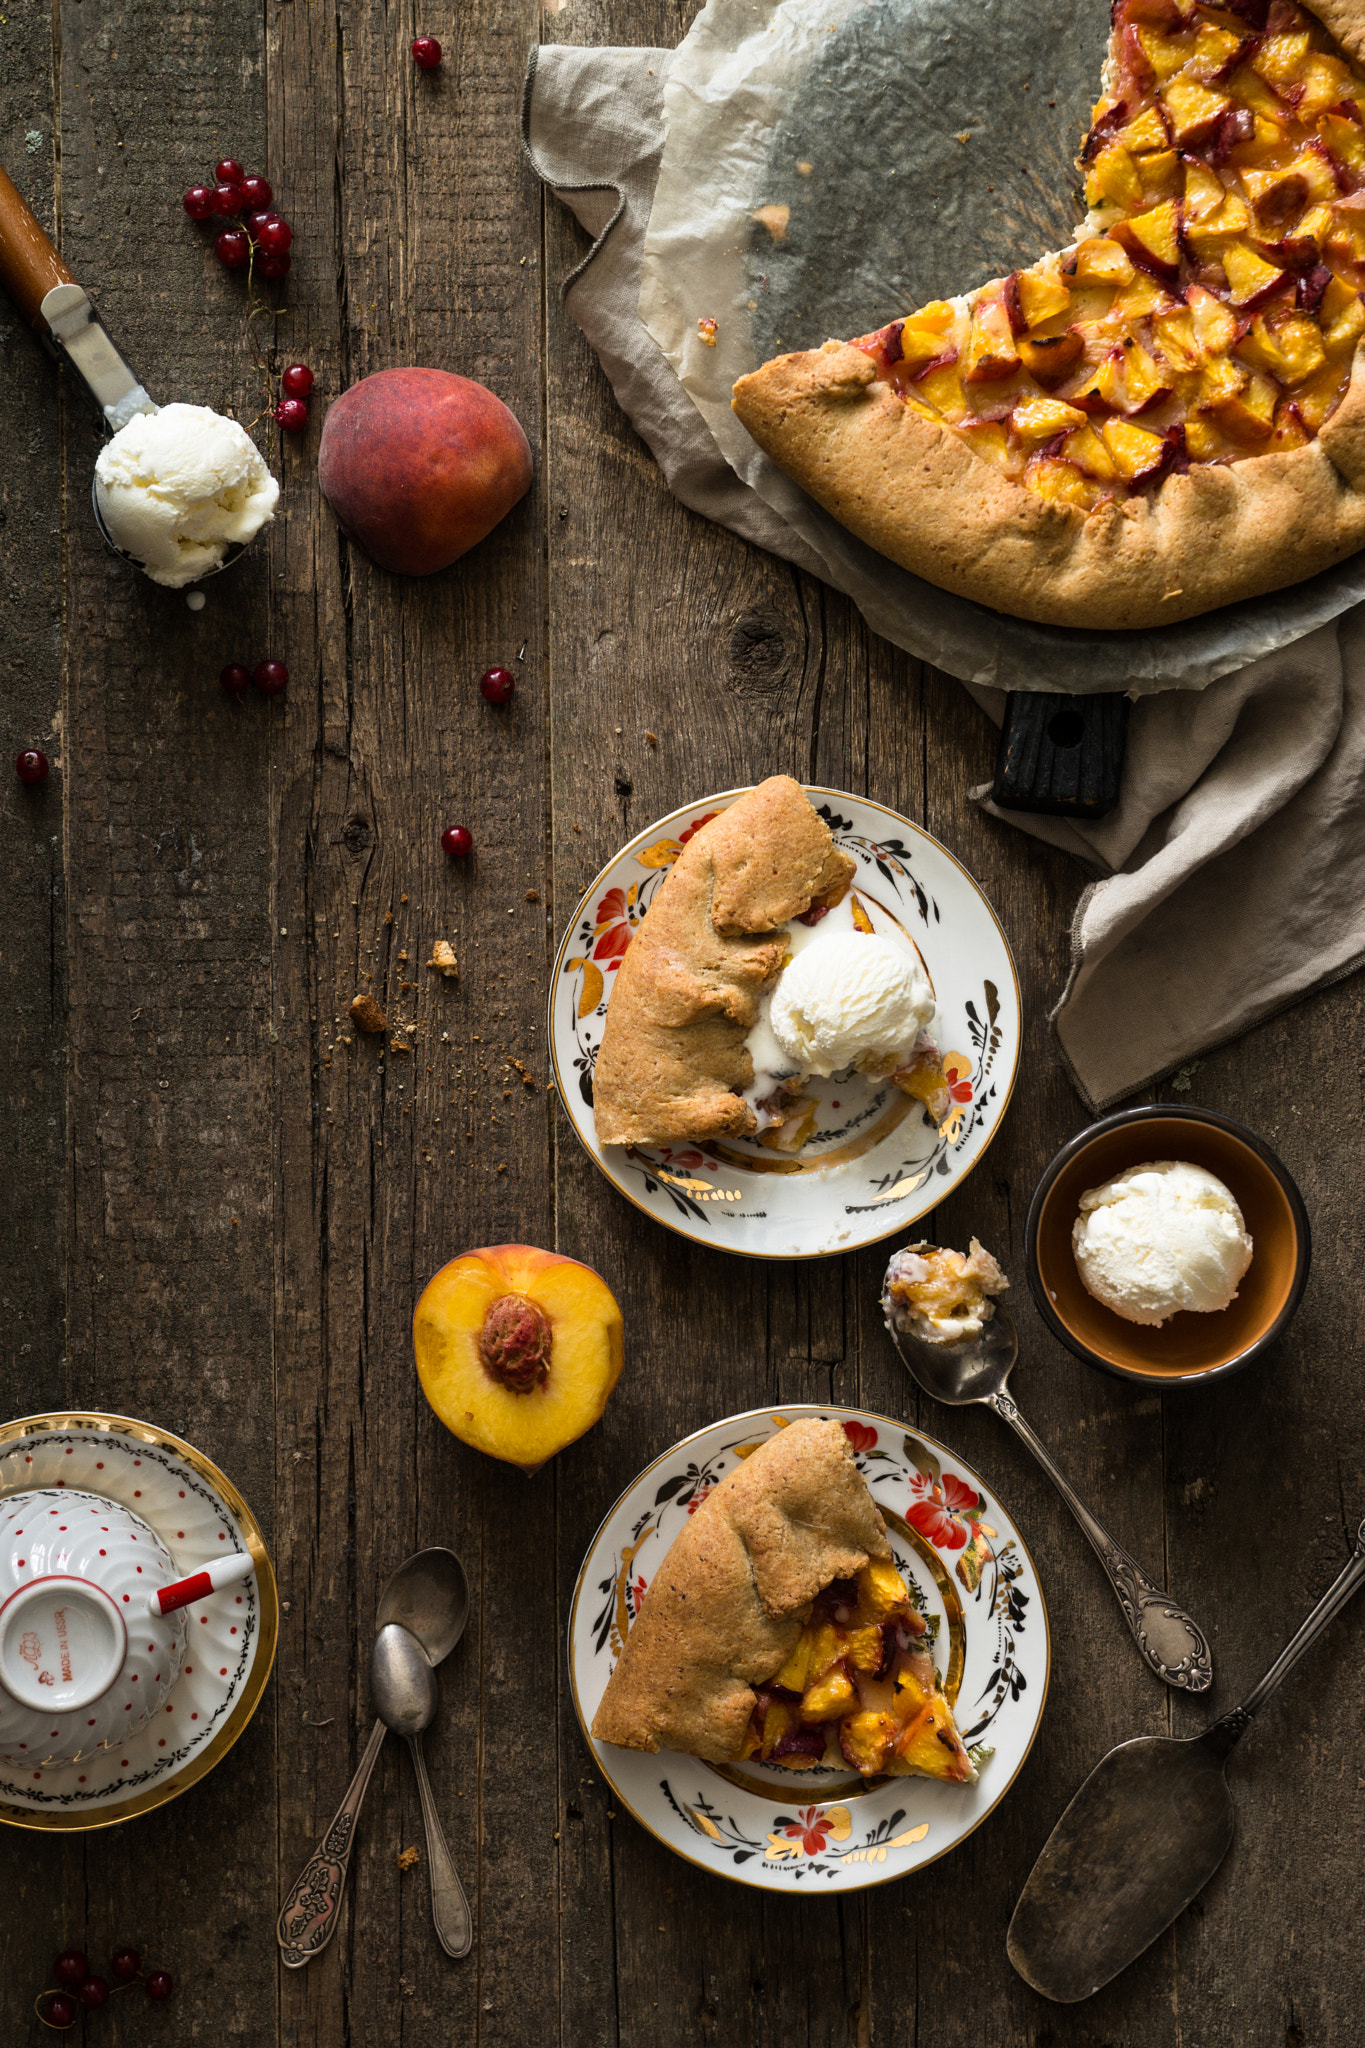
left=0, top=14, right=80, bottom=2040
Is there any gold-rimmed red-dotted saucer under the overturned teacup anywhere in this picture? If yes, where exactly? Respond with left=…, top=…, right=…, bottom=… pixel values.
left=0, top=1413, right=278, bottom=1829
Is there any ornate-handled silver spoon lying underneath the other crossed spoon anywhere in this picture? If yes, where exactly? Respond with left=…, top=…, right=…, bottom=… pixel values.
left=274, top=1548, right=469, bottom=1970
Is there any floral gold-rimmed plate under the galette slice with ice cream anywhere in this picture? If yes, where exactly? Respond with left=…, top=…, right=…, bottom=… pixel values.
left=548, top=786, right=1019, bottom=1260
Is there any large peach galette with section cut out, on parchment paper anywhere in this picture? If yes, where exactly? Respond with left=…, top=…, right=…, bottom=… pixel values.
left=735, top=0, right=1365, bottom=627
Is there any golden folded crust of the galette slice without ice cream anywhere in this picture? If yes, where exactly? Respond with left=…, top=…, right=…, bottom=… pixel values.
left=591, top=1425, right=890, bottom=1763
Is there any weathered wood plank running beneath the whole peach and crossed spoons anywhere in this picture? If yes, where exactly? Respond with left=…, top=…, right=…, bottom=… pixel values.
left=272, top=4, right=559, bottom=2048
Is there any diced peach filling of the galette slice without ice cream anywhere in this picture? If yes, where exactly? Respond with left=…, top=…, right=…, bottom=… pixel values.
left=743, top=1559, right=976, bottom=1784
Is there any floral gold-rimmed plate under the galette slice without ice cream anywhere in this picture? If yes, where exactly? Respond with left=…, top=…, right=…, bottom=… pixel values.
left=569, top=1403, right=1050, bottom=1892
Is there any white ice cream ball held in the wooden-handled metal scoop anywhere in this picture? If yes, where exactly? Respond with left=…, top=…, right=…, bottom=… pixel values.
left=94, top=406, right=280, bottom=590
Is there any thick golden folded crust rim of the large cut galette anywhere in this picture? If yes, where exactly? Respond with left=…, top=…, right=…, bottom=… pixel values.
left=735, top=342, right=1365, bottom=629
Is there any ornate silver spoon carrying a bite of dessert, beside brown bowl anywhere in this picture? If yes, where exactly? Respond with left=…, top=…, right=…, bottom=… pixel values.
left=882, top=1262, right=1214, bottom=1692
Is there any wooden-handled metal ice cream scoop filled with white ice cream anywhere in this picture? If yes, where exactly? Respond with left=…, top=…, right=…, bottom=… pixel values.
left=0, top=170, right=280, bottom=590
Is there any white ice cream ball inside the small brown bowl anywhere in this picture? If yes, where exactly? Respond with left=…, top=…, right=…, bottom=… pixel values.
left=1070, top=1159, right=1252, bottom=1327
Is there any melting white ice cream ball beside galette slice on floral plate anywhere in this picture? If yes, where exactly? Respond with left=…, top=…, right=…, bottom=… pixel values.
left=767, top=930, right=933, bottom=1075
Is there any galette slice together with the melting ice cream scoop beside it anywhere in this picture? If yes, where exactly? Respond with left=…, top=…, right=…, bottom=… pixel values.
left=593, top=776, right=950, bottom=1151
